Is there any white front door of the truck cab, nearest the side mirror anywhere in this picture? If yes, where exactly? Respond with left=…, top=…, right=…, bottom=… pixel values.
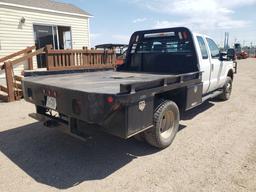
left=206, top=37, right=223, bottom=92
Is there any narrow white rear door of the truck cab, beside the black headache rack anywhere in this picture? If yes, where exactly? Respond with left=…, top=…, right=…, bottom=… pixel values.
left=196, top=35, right=211, bottom=94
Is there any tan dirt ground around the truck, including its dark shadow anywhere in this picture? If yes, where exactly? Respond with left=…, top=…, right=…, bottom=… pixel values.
left=0, top=59, right=256, bottom=192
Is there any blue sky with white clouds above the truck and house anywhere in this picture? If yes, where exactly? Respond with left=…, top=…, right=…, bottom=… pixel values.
left=62, top=0, right=256, bottom=46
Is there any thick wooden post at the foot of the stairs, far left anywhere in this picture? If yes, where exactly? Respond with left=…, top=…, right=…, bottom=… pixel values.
left=4, top=61, right=15, bottom=102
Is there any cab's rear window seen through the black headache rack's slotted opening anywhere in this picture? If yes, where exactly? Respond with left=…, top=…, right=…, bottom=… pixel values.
left=131, top=32, right=192, bottom=53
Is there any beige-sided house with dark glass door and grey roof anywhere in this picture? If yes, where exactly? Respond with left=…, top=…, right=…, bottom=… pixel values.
left=0, top=0, right=91, bottom=71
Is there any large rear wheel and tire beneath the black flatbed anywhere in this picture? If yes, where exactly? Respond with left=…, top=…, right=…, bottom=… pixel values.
left=144, top=101, right=180, bottom=149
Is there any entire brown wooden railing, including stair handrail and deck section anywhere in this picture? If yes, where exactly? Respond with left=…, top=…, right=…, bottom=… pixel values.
left=0, top=45, right=116, bottom=102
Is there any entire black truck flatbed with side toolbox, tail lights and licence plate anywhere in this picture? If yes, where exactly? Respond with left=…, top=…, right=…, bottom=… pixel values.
left=23, top=71, right=202, bottom=138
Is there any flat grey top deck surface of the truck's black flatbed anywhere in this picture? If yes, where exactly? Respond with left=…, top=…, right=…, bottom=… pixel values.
left=25, top=71, right=174, bottom=94
